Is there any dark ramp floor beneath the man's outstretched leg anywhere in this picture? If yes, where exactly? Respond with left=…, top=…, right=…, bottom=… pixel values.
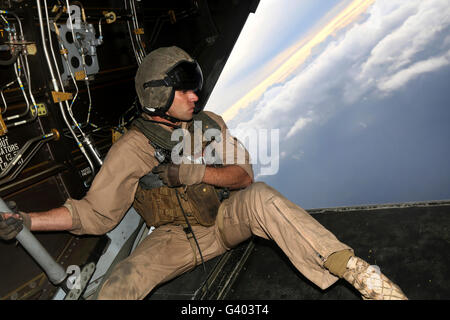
left=149, top=202, right=450, bottom=300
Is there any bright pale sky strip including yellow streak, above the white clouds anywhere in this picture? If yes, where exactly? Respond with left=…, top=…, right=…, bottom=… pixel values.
left=207, top=0, right=374, bottom=117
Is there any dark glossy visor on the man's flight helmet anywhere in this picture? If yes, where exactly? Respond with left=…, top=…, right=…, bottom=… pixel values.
left=167, top=61, right=203, bottom=91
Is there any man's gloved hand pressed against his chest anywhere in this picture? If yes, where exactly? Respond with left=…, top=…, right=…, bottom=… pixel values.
left=152, top=163, right=206, bottom=187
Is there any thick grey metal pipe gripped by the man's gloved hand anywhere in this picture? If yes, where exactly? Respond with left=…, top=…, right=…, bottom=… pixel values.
left=0, top=198, right=67, bottom=285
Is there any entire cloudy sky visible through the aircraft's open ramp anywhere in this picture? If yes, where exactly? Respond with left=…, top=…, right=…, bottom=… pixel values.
left=205, top=0, right=450, bottom=209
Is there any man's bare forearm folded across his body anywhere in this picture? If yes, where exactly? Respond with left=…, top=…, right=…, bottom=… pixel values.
left=203, top=165, right=253, bottom=189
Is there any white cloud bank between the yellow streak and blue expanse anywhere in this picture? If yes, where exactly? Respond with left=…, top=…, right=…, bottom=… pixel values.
left=230, top=0, right=450, bottom=138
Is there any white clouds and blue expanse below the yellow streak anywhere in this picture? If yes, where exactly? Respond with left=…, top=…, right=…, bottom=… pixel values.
left=213, top=0, right=450, bottom=207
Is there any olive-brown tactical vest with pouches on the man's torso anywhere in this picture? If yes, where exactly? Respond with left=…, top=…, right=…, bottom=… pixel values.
left=132, top=112, right=227, bottom=227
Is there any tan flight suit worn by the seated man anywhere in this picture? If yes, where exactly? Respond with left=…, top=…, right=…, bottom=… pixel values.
left=65, top=112, right=351, bottom=299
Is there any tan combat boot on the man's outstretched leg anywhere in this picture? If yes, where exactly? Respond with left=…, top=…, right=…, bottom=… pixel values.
left=343, top=257, right=408, bottom=300
